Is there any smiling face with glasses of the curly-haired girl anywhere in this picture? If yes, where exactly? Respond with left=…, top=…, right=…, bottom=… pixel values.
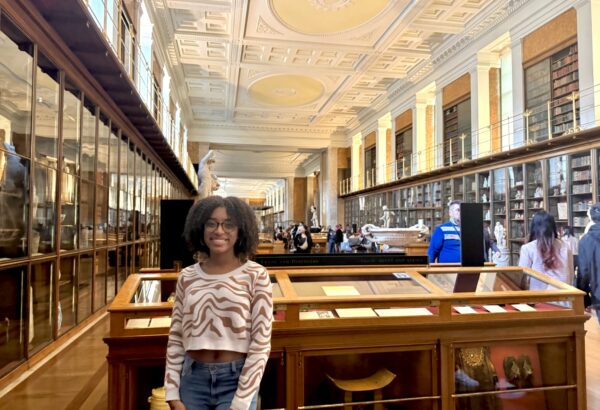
left=204, top=207, right=238, bottom=256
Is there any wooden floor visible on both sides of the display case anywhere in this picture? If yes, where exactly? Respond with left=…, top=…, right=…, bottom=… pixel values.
left=0, top=315, right=600, bottom=410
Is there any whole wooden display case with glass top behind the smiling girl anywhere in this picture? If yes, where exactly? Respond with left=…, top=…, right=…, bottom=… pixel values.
left=105, top=266, right=588, bottom=410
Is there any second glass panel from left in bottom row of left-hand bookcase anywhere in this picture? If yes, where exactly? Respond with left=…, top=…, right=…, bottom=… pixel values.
left=28, top=262, right=54, bottom=352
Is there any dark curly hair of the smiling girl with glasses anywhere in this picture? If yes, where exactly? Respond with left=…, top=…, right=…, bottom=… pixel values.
left=183, top=196, right=258, bottom=262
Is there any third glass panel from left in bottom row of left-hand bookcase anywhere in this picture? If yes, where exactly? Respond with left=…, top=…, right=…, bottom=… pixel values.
left=57, top=256, right=77, bottom=335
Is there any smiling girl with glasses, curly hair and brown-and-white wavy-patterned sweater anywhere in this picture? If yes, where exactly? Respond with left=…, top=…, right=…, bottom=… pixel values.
left=165, top=196, right=273, bottom=410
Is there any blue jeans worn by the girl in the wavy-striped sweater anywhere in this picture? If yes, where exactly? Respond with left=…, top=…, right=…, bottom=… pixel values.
left=179, top=354, right=256, bottom=410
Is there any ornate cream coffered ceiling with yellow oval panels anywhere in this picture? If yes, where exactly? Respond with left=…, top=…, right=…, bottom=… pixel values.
left=151, top=0, right=502, bottom=196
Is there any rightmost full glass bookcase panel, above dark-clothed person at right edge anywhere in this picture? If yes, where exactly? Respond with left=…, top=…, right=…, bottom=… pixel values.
left=570, top=151, right=594, bottom=237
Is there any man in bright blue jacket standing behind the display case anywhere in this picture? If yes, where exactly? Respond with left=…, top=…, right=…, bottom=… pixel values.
left=427, top=200, right=462, bottom=263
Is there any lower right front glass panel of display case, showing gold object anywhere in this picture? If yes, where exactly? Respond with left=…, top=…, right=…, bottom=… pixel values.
left=453, top=341, right=576, bottom=409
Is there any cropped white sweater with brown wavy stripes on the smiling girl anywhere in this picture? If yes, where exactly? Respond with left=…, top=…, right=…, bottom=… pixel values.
left=165, top=261, right=273, bottom=410
